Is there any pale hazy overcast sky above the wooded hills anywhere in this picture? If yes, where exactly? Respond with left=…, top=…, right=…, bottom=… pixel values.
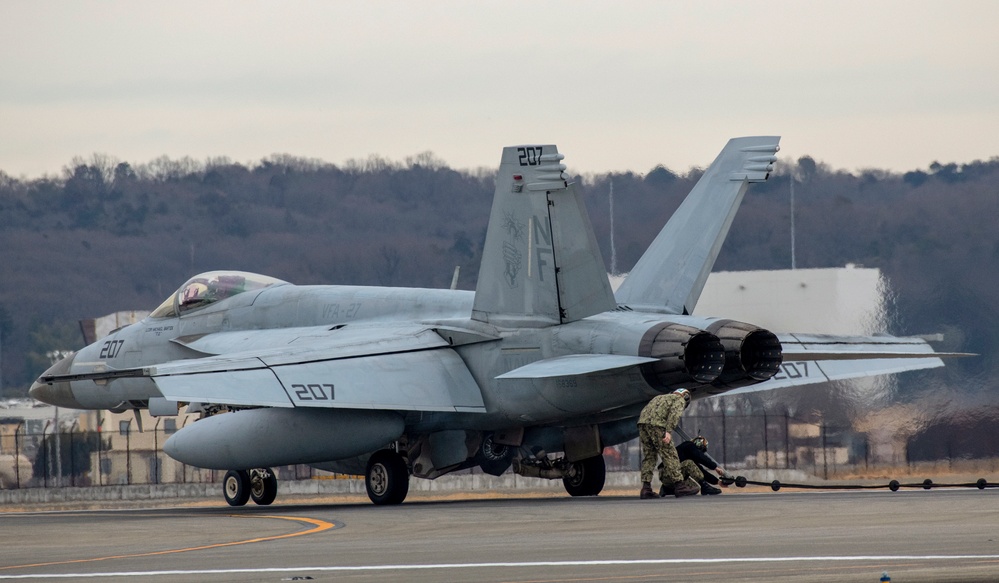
left=0, top=0, right=999, bottom=178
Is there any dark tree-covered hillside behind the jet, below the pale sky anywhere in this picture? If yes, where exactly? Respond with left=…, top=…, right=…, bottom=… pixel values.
left=0, top=153, right=999, bottom=416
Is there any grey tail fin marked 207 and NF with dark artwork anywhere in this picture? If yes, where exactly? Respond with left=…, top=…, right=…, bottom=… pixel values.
left=472, top=146, right=616, bottom=325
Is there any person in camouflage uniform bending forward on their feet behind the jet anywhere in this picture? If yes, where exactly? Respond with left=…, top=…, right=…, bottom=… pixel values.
left=638, top=389, right=698, bottom=500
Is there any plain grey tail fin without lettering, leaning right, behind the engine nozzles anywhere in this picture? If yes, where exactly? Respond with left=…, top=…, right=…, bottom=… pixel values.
left=616, top=136, right=780, bottom=314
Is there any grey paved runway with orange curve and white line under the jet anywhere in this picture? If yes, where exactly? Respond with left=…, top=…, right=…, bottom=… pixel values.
left=0, top=488, right=999, bottom=583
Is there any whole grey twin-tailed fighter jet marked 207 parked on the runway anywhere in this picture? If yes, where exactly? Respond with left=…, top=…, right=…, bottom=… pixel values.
left=30, top=136, right=942, bottom=506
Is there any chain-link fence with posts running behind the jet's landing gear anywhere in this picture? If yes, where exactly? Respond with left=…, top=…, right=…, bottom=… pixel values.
left=0, top=412, right=980, bottom=489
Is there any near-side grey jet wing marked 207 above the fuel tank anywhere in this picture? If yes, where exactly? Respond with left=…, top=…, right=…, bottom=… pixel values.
left=143, top=324, right=485, bottom=412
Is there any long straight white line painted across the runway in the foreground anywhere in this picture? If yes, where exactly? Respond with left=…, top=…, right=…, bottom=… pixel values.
left=0, top=555, right=999, bottom=580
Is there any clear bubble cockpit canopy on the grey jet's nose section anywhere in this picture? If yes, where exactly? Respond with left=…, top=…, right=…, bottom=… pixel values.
left=149, top=271, right=288, bottom=318
